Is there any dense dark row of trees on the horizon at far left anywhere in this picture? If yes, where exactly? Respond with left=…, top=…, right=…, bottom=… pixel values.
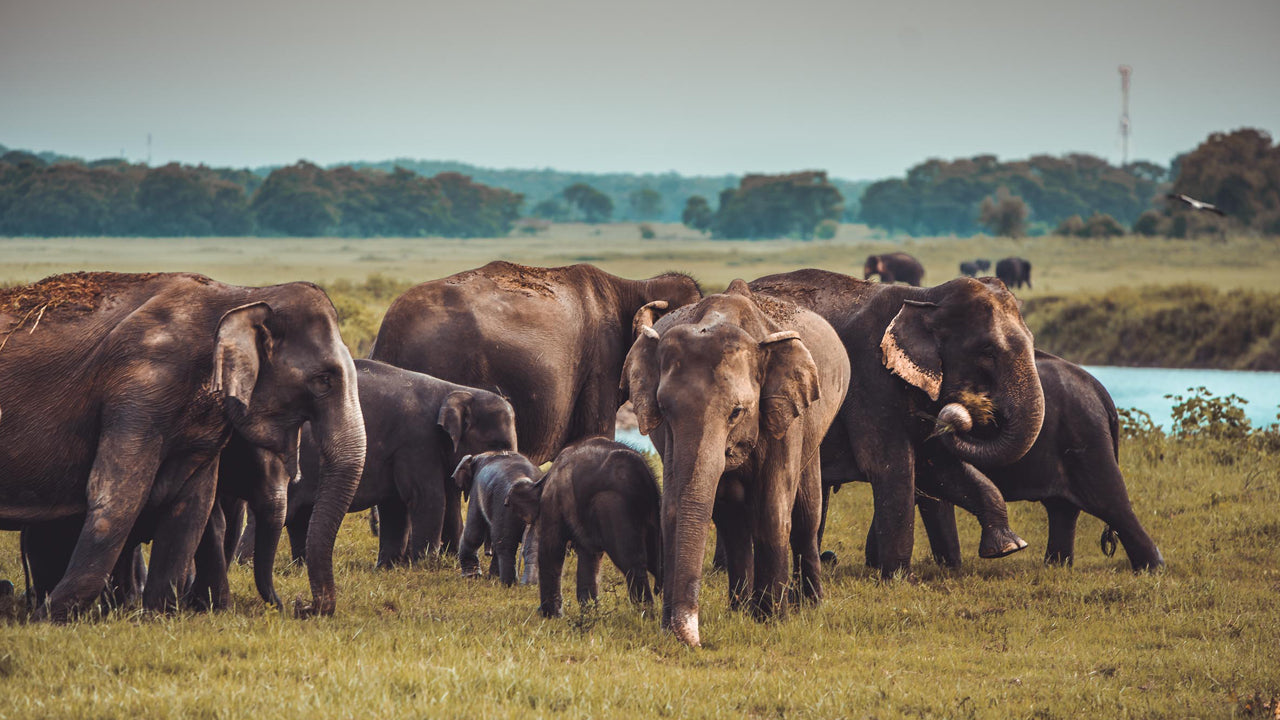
left=0, top=151, right=522, bottom=237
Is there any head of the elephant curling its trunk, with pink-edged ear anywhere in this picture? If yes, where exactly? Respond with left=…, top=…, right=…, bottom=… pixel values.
left=881, top=278, right=1044, bottom=468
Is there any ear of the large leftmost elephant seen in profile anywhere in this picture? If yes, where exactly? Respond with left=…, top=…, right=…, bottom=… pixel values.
left=212, top=302, right=271, bottom=420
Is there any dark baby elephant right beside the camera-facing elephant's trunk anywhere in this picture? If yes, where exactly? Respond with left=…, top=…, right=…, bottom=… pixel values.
left=507, top=437, right=662, bottom=618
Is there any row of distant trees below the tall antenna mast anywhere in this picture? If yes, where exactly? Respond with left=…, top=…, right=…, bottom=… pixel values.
left=860, top=154, right=1167, bottom=236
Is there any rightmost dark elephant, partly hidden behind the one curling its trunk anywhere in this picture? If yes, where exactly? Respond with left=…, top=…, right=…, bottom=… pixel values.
left=919, top=351, right=1165, bottom=571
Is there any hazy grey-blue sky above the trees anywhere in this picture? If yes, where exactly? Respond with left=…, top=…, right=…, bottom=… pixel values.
left=0, top=0, right=1280, bottom=179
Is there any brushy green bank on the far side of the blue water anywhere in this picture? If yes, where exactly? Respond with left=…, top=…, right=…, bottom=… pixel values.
left=1023, top=284, right=1280, bottom=370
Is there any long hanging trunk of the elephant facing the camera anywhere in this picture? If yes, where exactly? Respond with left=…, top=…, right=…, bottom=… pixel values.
left=662, top=433, right=724, bottom=647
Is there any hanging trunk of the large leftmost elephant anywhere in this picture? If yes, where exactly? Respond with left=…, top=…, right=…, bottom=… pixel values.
left=296, top=384, right=365, bottom=615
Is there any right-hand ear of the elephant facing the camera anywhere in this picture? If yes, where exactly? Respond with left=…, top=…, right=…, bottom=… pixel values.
left=760, top=331, right=820, bottom=438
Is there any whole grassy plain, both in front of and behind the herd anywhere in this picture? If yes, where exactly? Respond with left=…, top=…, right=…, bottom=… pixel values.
left=0, top=224, right=1280, bottom=719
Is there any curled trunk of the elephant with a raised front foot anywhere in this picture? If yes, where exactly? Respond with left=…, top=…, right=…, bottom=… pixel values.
left=942, top=351, right=1044, bottom=468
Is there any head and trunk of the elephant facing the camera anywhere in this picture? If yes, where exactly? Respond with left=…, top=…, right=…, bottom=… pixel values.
left=622, top=281, right=818, bottom=646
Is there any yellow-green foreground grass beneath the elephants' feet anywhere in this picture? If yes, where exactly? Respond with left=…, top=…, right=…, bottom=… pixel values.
left=0, top=439, right=1280, bottom=717
